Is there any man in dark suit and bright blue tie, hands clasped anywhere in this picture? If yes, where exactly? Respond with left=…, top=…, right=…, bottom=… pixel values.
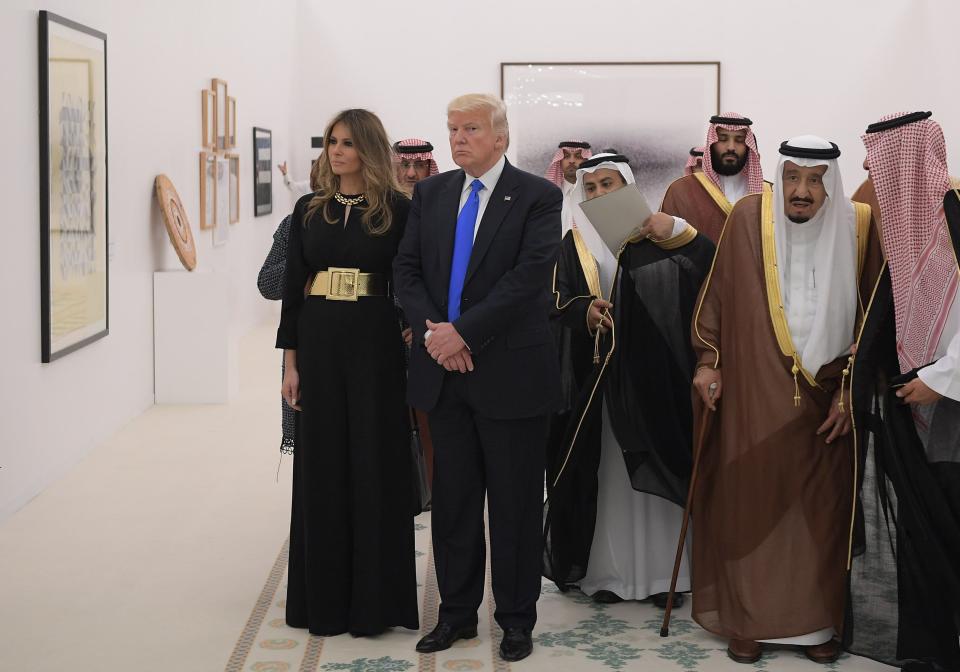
left=394, top=94, right=562, bottom=660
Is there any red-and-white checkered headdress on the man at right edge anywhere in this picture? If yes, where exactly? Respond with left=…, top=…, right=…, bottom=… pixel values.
left=861, top=113, right=960, bottom=373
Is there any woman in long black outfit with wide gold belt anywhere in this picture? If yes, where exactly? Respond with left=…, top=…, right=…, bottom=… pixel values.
left=277, top=109, right=419, bottom=636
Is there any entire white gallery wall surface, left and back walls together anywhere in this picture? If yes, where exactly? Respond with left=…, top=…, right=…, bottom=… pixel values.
left=0, top=0, right=960, bottom=520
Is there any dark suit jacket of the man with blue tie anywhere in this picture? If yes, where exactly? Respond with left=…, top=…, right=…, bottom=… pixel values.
left=393, top=161, right=563, bottom=418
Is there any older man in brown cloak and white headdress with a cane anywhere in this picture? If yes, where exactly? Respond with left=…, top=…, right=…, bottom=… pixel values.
left=691, top=135, right=882, bottom=663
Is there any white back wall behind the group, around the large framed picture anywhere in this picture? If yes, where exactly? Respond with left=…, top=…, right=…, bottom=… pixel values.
left=294, top=0, right=960, bottom=193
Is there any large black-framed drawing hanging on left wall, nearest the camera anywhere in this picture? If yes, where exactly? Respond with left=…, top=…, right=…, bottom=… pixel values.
left=39, top=11, right=109, bottom=362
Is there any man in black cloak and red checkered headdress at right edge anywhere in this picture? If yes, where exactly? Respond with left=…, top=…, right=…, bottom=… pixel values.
left=850, top=112, right=960, bottom=671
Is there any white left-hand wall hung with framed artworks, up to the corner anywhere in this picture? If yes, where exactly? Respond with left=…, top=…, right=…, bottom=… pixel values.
left=0, top=0, right=296, bottom=520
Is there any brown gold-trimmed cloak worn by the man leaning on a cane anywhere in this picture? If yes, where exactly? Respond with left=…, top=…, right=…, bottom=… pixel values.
left=692, top=193, right=882, bottom=640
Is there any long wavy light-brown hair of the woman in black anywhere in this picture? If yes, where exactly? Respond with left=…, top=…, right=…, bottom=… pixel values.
left=305, top=108, right=403, bottom=236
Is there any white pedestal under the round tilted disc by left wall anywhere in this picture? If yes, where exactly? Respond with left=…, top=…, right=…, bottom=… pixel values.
left=153, top=271, right=239, bottom=404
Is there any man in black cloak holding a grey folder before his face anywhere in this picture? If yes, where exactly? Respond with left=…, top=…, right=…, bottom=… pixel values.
left=543, top=154, right=715, bottom=606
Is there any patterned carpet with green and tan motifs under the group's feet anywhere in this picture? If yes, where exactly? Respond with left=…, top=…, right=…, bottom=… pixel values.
left=226, top=513, right=894, bottom=672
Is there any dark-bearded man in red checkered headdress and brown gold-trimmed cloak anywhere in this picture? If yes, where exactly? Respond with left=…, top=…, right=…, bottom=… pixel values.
left=660, top=112, right=763, bottom=243
